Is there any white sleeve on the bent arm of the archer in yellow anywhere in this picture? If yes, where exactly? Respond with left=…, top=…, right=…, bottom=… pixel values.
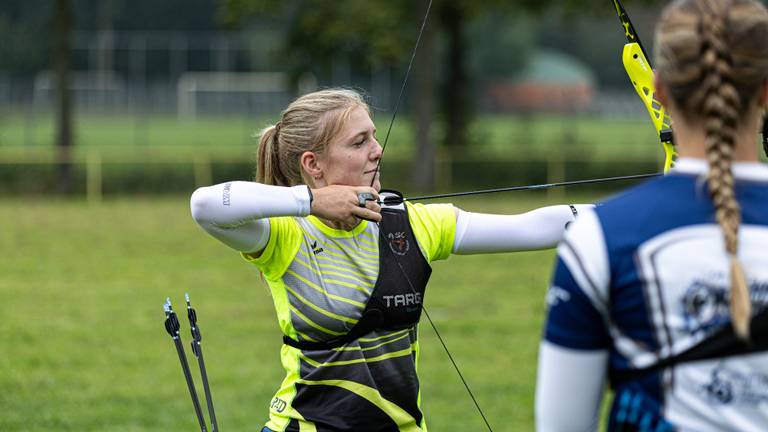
left=190, top=181, right=310, bottom=252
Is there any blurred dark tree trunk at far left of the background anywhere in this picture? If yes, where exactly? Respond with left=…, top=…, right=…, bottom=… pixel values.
left=54, top=0, right=73, bottom=194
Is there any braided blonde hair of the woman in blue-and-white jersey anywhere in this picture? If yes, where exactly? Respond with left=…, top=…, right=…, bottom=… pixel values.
left=656, top=0, right=768, bottom=340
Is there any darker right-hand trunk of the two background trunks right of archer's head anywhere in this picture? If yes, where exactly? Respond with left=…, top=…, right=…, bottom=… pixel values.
left=442, top=2, right=472, bottom=154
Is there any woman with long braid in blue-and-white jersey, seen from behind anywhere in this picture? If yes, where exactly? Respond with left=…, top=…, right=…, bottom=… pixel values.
left=536, top=0, right=768, bottom=432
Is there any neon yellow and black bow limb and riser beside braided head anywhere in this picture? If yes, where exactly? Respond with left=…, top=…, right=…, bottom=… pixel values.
left=611, top=0, right=677, bottom=172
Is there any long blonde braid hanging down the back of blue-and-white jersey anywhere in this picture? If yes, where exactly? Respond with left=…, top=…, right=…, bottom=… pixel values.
left=701, top=0, right=751, bottom=339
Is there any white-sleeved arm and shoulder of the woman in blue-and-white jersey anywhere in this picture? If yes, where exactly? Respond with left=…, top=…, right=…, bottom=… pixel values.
left=536, top=210, right=611, bottom=432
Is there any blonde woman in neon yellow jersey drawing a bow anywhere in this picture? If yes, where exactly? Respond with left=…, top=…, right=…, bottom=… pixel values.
left=191, top=89, right=591, bottom=432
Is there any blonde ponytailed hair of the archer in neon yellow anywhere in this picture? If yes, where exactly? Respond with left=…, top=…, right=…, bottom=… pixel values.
left=256, top=88, right=370, bottom=186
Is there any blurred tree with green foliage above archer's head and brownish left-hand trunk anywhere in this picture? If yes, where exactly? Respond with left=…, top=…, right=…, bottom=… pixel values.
left=220, top=0, right=435, bottom=190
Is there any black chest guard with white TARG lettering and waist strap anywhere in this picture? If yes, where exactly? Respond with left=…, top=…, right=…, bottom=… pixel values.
left=283, top=194, right=432, bottom=350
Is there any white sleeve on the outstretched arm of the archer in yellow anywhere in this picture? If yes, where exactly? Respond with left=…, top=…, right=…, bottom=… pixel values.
left=453, top=204, right=594, bottom=255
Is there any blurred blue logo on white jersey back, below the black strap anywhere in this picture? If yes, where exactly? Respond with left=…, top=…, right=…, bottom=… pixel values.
left=701, top=362, right=768, bottom=406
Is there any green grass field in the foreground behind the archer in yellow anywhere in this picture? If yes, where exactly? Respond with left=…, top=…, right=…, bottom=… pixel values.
left=0, top=193, right=616, bottom=432
